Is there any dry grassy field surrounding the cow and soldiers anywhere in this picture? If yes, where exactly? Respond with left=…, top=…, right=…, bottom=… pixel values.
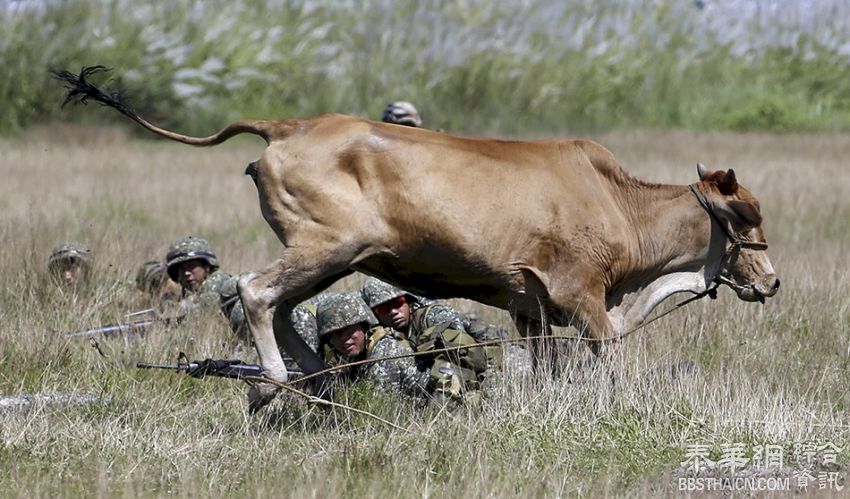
left=0, top=125, right=850, bottom=498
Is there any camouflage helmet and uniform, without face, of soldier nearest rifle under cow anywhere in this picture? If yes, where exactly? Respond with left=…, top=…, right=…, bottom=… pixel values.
left=316, top=293, right=428, bottom=397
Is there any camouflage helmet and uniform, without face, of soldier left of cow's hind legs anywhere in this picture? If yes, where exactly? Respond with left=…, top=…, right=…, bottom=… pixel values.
left=165, top=236, right=230, bottom=317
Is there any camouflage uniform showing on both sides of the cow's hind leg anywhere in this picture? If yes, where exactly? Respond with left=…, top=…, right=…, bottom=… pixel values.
left=219, top=273, right=327, bottom=356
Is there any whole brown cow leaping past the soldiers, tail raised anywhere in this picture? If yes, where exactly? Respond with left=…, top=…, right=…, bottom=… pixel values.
left=57, top=68, right=779, bottom=408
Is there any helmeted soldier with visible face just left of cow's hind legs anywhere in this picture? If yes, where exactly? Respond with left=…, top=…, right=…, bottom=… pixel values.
left=165, top=236, right=230, bottom=317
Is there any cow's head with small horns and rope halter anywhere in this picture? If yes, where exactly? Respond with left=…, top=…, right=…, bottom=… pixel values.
left=697, top=163, right=779, bottom=303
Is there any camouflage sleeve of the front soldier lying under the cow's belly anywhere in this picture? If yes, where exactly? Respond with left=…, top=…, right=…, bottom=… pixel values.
left=363, top=336, right=428, bottom=397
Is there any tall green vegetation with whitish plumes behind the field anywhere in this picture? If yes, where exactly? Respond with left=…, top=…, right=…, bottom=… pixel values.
left=0, top=0, right=850, bottom=134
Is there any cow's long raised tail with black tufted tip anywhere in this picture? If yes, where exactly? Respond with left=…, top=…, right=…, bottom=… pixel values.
left=51, top=66, right=280, bottom=146
